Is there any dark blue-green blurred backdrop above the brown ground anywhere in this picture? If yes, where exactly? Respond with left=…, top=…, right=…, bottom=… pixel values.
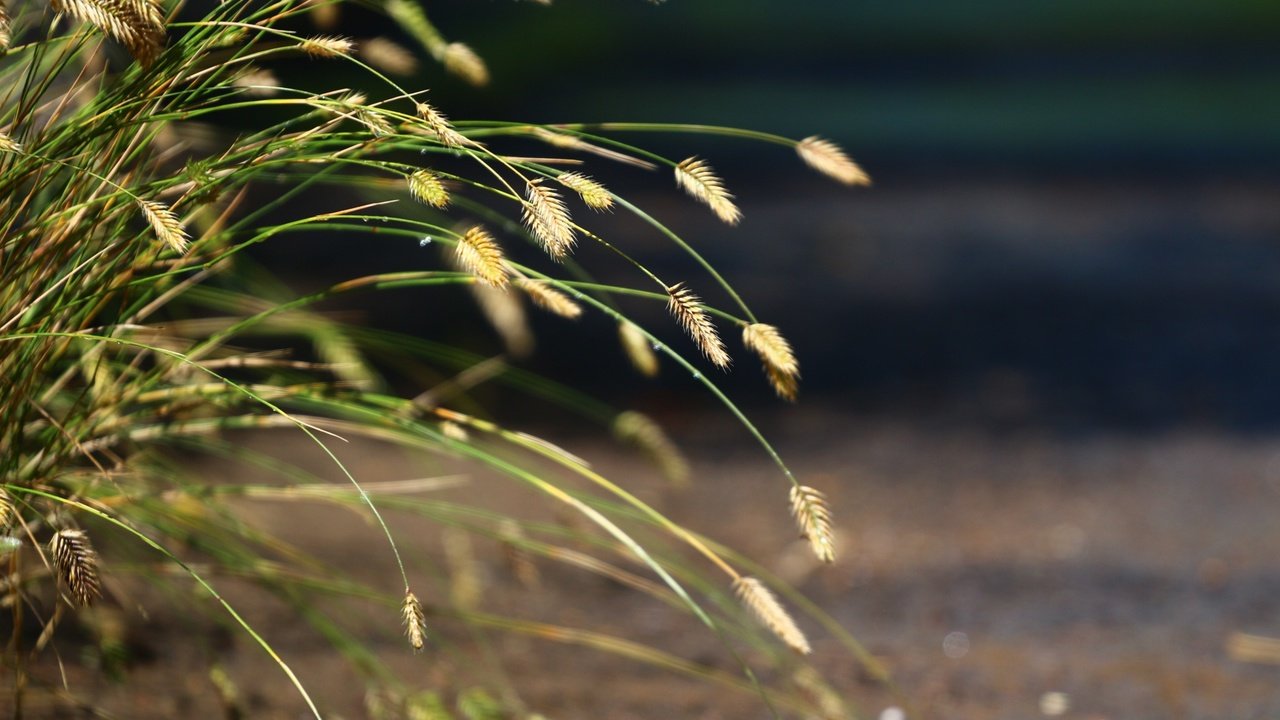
left=275, top=0, right=1280, bottom=429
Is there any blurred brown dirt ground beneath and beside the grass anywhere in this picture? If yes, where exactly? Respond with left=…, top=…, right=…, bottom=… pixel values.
left=10, top=411, right=1280, bottom=720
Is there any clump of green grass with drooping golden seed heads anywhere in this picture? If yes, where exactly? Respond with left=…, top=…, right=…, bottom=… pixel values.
left=0, top=0, right=883, bottom=717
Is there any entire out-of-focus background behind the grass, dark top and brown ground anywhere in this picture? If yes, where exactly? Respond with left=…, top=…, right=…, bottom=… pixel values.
left=249, top=0, right=1280, bottom=719
